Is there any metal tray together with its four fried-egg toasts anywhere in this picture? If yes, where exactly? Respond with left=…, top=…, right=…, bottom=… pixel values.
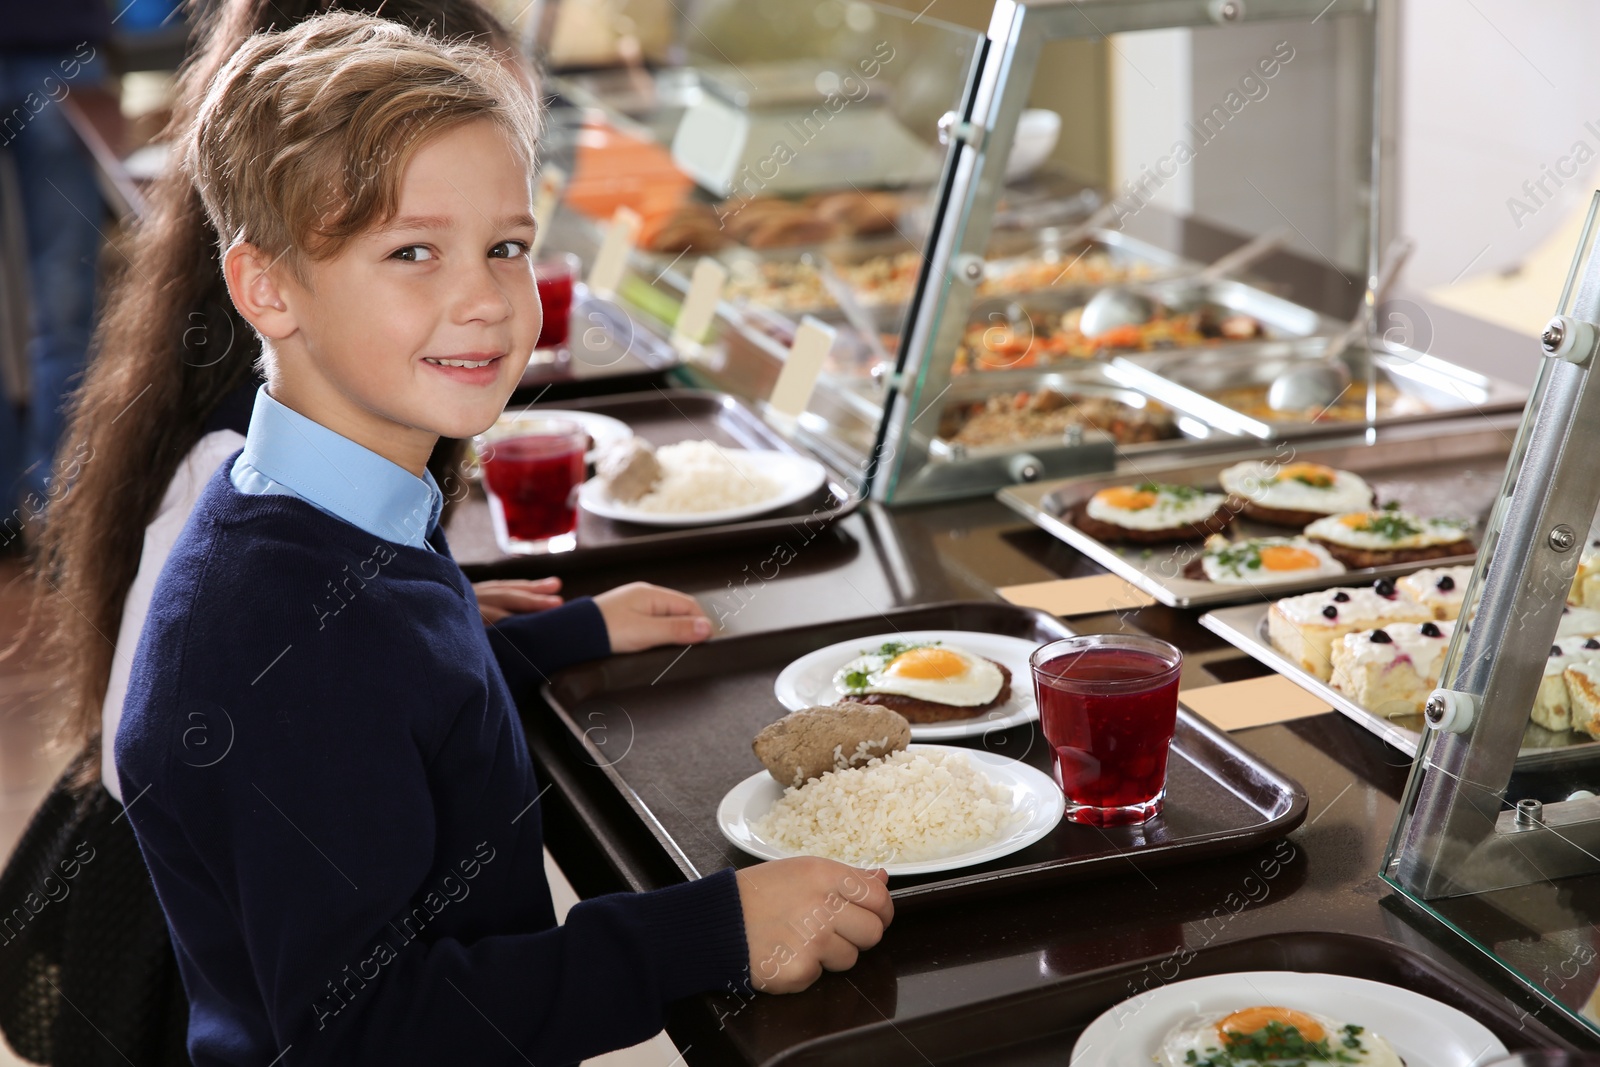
left=998, top=416, right=1517, bottom=608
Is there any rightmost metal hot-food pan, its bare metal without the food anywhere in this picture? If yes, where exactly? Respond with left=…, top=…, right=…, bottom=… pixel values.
left=1115, top=339, right=1528, bottom=440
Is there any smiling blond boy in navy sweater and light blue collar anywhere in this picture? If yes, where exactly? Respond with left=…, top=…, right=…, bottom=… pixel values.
left=117, top=14, right=893, bottom=1067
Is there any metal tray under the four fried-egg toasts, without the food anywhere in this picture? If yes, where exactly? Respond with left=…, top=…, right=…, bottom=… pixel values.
left=998, top=419, right=1517, bottom=608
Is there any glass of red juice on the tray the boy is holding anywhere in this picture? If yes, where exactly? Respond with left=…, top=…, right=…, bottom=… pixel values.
left=1029, top=633, right=1184, bottom=825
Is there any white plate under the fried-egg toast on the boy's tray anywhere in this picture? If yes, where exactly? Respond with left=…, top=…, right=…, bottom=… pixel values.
left=773, top=630, right=1038, bottom=741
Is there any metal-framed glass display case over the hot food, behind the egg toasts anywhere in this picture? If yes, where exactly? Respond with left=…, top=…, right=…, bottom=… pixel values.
left=534, top=0, right=1526, bottom=502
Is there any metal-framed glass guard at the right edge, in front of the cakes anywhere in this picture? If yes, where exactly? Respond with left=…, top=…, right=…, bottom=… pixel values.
left=1384, top=195, right=1600, bottom=1030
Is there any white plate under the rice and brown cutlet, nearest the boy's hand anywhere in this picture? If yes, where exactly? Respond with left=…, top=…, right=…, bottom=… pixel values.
left=717, top=745, right=1068, bottom=876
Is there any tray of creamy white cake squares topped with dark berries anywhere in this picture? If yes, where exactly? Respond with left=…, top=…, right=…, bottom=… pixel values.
left=1200, top=542, right=1600, bottom=757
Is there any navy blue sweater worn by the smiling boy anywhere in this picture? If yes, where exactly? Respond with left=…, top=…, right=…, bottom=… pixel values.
left=115, top=461, right=747, bottom=1067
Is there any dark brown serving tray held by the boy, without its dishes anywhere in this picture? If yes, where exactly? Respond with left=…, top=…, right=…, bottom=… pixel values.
left=544, top=603, right=1306, bottom=902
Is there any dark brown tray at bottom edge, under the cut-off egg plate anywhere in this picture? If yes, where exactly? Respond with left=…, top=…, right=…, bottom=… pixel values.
left=766, top=933, right=1576, bottom=1067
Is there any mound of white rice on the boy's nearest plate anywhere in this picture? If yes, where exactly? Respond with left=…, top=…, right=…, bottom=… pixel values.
left=750, top=750, right=1014, bottom=867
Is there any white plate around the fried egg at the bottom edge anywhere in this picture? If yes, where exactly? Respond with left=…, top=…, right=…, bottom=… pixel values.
left=1072, top=971, right=1506, bottom=1067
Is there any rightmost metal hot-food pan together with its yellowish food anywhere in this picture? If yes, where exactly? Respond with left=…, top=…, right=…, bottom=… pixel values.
left=1115, top=338, right=1528, bottom=440
